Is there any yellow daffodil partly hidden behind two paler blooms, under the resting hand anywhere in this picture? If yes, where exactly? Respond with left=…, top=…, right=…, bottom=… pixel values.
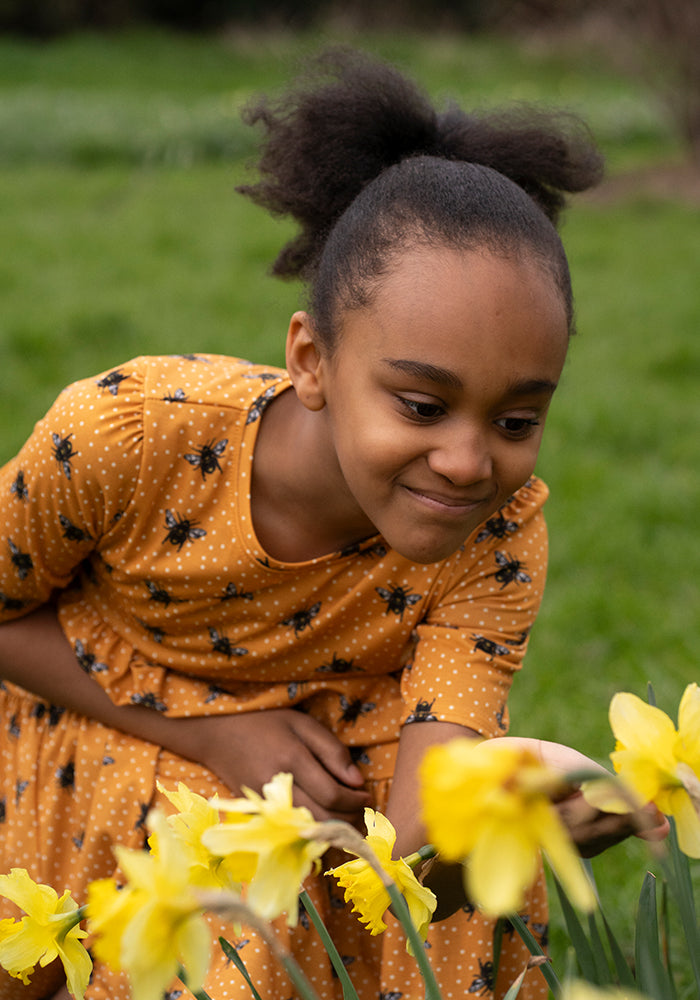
left=158, top=782, right=257, bottom=892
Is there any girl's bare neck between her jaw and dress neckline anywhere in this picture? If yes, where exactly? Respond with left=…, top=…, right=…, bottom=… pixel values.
left=251, top=389, right=376, bottom=562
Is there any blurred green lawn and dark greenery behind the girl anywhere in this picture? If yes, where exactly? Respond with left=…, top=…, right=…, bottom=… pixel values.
left=0, top=0, right=700, bottom=984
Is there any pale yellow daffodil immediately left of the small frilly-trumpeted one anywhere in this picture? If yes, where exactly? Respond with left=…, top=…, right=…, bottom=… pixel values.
left=202, top=774, right=328, bottom=927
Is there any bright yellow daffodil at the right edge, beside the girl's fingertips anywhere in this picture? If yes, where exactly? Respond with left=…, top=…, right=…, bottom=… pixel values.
left=584, top=684, right=700, bottom=858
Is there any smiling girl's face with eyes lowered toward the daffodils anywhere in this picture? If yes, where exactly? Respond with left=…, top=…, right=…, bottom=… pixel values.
left=294, top=249, right=568, bottom=563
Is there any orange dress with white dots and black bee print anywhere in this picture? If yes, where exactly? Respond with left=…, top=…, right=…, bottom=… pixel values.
left=0, top=355, right=547, bottom=1000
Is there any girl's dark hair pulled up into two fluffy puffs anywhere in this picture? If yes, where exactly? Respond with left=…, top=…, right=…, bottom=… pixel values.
left=238, top=48, right=602, bottom=351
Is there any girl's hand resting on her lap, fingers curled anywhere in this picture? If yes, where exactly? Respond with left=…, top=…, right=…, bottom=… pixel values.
left=176, top=708, right=371, bottom=829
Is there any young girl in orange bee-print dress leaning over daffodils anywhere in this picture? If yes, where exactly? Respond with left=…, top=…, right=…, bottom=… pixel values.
left=0, top=53, right=644, bottom=1000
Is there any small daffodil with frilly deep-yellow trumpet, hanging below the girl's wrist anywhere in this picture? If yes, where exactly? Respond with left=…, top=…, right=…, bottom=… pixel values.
left=326, top=809, right=437, bottom=941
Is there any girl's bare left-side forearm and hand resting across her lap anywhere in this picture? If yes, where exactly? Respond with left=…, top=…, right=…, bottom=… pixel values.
left=0, top=606, right=369, bottom=824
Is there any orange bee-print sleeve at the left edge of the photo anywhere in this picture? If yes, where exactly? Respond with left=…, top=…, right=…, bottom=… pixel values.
left=0, top=369, right=143, bottom=621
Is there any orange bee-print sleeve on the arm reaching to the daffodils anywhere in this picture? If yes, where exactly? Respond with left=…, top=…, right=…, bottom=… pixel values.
left=401, top=479, right=547, bottom=738
